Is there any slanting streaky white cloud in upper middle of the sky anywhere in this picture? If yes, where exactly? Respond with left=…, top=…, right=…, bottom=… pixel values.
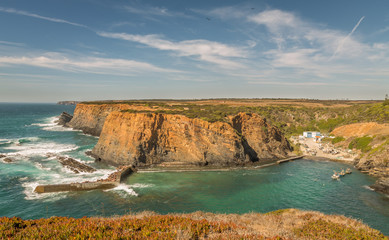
left=97, top=32, right=247, bottom=68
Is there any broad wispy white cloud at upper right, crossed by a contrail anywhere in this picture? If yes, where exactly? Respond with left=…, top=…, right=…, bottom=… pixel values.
left=242, top=7, right=389, bottom=81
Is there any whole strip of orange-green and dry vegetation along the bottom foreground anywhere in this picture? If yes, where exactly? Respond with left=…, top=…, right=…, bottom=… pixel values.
left=0, top=209, right=388, bottom=239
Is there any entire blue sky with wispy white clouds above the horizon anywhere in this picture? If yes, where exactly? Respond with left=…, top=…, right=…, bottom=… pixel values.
left=0, top=0, right=389, bottom=102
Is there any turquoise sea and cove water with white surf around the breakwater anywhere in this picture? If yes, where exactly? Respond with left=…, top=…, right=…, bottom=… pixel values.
left=0, top=104, right=389, bottom=235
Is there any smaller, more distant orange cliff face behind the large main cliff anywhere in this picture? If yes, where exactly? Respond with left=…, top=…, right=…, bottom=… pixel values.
left=67, top=103, right=130, bottom=136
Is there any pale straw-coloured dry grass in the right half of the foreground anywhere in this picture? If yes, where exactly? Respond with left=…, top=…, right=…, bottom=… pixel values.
left=175, top=209, right=388, bottom=239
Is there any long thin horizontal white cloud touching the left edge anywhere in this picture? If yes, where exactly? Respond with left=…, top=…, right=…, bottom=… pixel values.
left=0, top=52, right=180, bottom=76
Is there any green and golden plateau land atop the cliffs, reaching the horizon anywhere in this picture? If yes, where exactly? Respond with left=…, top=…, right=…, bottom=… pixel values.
left=80, top=99, right=389, bottom=136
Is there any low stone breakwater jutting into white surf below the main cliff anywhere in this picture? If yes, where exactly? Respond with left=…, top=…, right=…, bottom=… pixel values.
left=34, top=166, right=136, bottom=193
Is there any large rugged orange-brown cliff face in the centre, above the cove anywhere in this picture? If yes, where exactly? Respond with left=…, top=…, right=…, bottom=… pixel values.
left=92, top=112, right=290, bottom=165
